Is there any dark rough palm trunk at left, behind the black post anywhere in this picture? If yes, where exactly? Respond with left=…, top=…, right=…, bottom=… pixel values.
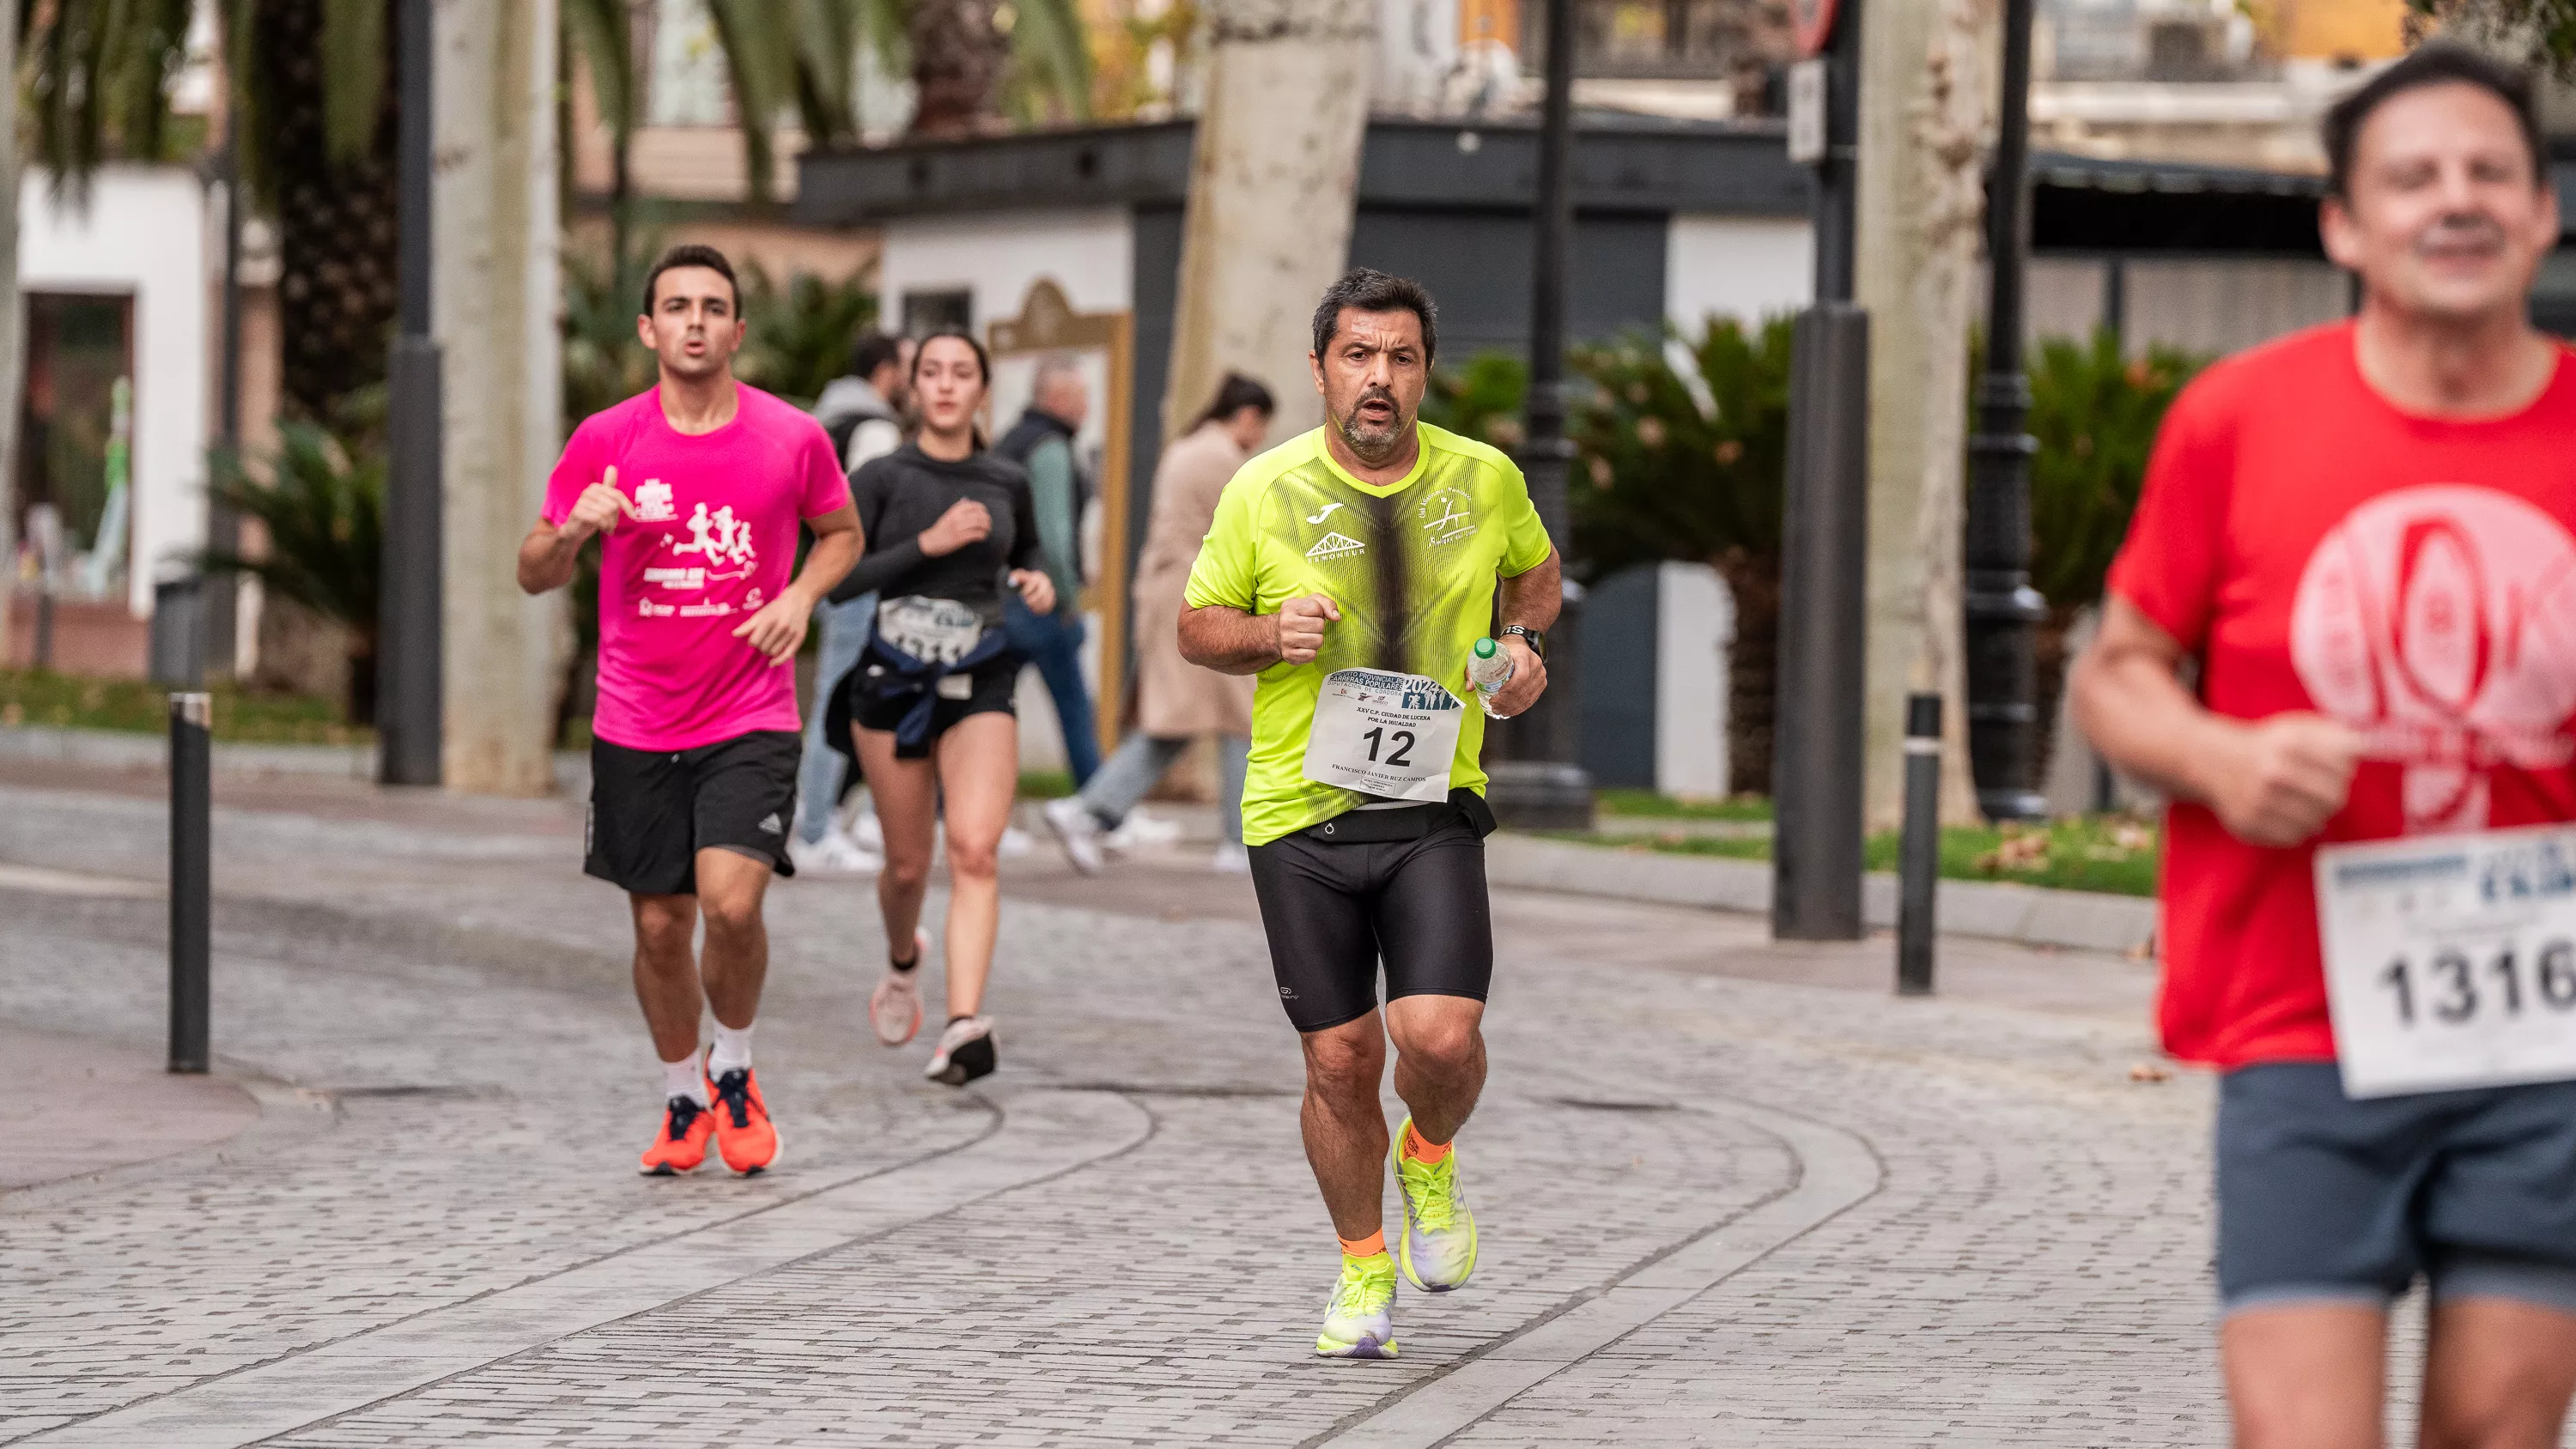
left=250, top=0, right=399, bottom=422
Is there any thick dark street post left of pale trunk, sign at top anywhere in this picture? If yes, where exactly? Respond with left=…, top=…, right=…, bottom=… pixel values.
left=1772, top=0, right=1870, bottom=942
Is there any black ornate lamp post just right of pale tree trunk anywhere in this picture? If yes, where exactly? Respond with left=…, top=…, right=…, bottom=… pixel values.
left=1963, top=0, right=2048, bottom=821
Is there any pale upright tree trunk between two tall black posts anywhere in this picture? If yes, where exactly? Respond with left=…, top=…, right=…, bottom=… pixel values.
left=1855, top=0, right=1999, bottom=831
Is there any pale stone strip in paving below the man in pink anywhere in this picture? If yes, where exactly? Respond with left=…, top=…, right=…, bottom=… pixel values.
left=23, top=1091, right=1154, bottom=1449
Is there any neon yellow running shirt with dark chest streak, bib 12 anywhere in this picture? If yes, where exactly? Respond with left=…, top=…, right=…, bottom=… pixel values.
left=1182, top=422, right=1551, bottom=844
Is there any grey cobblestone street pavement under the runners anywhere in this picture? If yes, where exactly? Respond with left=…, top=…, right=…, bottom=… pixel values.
left=0, top=779, right=2298, bottom=1446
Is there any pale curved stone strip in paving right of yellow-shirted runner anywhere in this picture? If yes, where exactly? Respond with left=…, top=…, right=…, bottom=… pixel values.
left=1298, top=1096, right=1880, bottom=1449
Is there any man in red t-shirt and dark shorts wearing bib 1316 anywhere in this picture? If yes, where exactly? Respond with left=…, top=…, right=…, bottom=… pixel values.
left=2074, top=46, right=2576, bottom=1446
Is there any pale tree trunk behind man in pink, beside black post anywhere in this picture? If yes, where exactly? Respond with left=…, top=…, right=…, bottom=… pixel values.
left=430, top=0, right=572, bottom=795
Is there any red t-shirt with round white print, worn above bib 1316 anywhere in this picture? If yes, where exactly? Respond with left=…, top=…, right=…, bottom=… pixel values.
left=2110, top=322, right=2576, bottom=1068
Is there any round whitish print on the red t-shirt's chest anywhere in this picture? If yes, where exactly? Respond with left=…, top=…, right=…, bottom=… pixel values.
left=2290, top=484, right=2576, bottom=834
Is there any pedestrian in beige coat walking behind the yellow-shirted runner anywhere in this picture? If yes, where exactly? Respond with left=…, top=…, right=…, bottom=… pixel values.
left=1046, top=373, right=1275, bottom=875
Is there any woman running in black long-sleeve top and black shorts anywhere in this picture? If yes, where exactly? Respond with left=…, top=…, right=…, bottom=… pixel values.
left=832, top=332, right=1056, bottom=1086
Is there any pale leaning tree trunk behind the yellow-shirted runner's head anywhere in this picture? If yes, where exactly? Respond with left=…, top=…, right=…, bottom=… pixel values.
left=1162, top=0, right=1376, bottom=438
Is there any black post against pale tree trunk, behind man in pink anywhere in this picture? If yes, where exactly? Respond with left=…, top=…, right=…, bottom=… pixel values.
left=376, top=0, right=446, bottom=785
